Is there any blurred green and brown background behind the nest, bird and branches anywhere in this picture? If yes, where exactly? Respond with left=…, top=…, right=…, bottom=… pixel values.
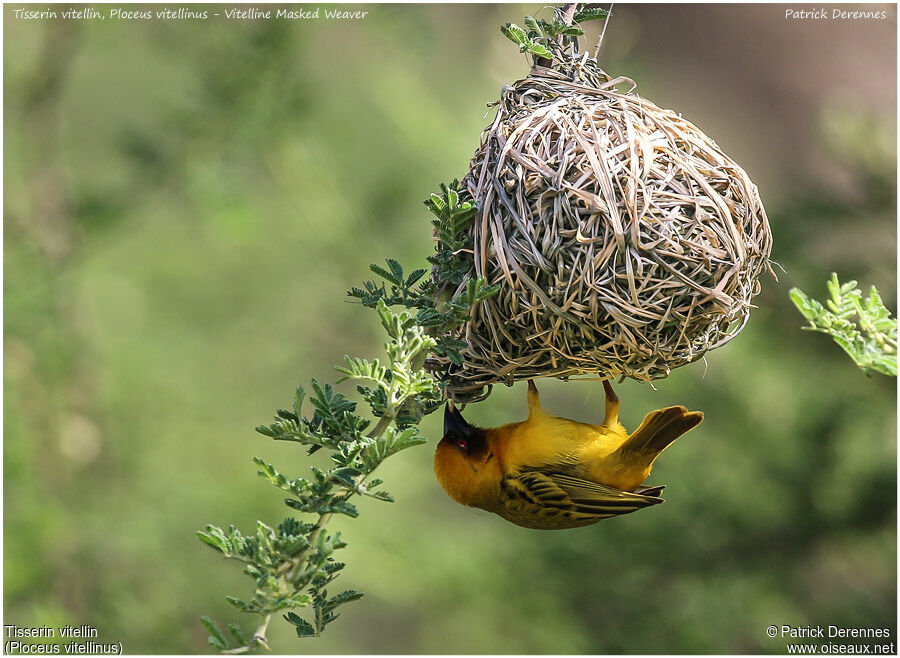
left=3, top=5, right=897, bottom=654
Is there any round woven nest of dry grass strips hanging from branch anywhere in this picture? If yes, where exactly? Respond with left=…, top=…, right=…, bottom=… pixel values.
left=447, top=56, right=772, bottom=401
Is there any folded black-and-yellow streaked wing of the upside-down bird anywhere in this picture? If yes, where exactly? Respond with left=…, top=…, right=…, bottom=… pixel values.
left=500, top=470, right=663, bottom=528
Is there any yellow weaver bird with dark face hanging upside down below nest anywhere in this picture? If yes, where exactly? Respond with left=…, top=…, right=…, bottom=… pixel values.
left=434, top=381, right=703, bottom=530
